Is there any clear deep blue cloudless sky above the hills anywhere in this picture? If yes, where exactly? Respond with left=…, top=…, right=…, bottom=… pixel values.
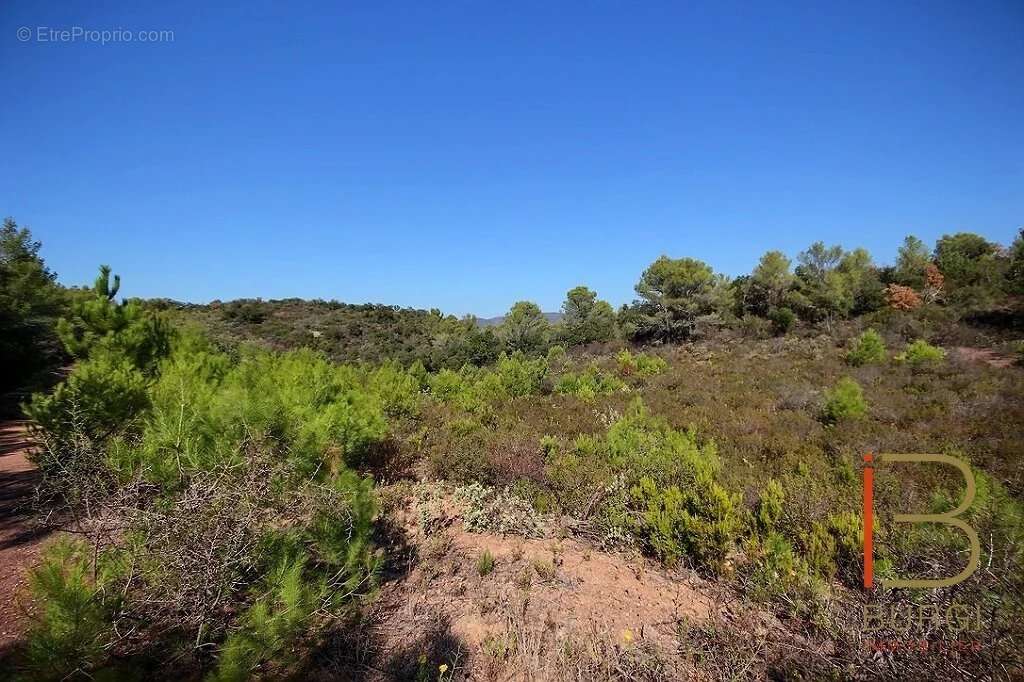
left=0, top=0, right=1024, bottom=316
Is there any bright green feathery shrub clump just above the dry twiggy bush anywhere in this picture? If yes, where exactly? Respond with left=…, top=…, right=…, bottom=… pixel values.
left=135, top=349, right=389, bottom=481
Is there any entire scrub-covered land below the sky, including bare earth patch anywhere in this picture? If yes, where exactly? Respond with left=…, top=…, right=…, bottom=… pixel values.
left=3, top=216, right=1024, bottom=680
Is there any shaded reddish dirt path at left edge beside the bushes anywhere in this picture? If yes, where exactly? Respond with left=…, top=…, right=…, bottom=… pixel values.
left=0, top=421, right=46, bottom=650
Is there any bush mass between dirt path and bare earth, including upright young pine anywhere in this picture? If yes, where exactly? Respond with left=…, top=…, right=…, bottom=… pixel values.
left=16, top=271, right=391, bottom=680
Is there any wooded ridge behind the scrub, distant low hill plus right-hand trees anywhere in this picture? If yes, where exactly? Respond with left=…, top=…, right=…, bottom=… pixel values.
left=148, top=228, right=1024, bottom=370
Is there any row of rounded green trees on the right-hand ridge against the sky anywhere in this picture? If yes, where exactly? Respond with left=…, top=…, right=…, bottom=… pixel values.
left=481, top=229, right=1024, bottom=353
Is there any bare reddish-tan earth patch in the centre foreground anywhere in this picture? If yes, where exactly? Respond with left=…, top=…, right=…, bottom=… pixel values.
left=314, top=485, right=781, bottom=680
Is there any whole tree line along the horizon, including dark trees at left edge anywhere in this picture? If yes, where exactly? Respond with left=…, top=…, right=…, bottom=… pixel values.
left=0, top=218, right=1024, bottom=393
